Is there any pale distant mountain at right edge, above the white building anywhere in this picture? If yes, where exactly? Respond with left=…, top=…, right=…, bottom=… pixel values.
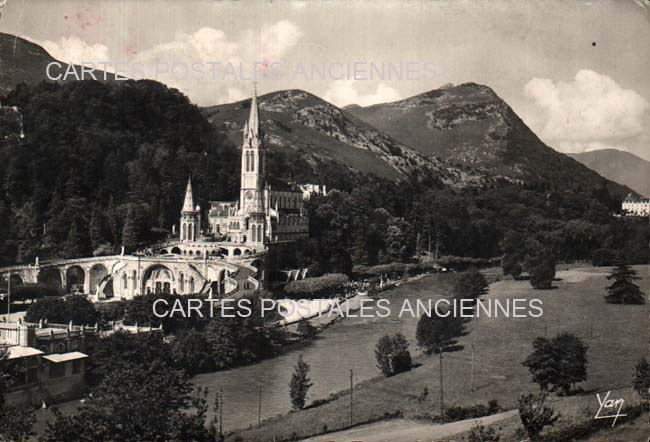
left=570, top=149, right=650, bottom=196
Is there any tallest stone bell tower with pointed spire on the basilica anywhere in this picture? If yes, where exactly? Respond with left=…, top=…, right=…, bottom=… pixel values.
left=239, top=88, right=268, bottom=243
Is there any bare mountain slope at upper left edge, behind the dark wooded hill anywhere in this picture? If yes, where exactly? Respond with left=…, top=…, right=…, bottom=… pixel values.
left=0, top=32, right=114, bottom=95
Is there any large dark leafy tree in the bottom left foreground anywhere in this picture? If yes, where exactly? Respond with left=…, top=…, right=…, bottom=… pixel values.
left=44, top=362, right=210, bottom=442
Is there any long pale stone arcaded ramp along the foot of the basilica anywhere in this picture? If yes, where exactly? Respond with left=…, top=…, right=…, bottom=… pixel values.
left=0, top=250, right=264, bottom=301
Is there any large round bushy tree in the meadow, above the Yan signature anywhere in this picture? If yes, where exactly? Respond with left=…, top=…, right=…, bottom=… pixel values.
left=524, top=332, right=588, bottom=394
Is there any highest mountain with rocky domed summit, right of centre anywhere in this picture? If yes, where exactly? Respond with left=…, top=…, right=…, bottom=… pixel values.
left=347, top=83, right=629, bottom=196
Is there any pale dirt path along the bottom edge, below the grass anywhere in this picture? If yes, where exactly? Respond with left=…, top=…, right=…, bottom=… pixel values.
left=305, top=410, right=517, bottom=442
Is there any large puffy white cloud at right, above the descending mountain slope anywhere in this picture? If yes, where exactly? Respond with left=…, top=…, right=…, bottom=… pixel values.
left=524, top=69, right=648, bottom=147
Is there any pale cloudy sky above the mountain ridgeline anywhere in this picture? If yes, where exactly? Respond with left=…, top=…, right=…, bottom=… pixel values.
left=0, top=0, right=650, bottom=160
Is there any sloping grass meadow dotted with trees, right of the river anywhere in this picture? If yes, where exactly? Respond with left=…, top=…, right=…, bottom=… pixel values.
left=229, top=266, right=650, bottom=441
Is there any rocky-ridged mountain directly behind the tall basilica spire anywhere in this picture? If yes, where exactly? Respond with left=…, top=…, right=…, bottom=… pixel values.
left=203, top=90, right=481, bottom=186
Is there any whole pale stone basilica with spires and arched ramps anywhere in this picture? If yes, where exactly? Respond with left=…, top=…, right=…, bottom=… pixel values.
left=0, top=90, right=318, bottom=302
